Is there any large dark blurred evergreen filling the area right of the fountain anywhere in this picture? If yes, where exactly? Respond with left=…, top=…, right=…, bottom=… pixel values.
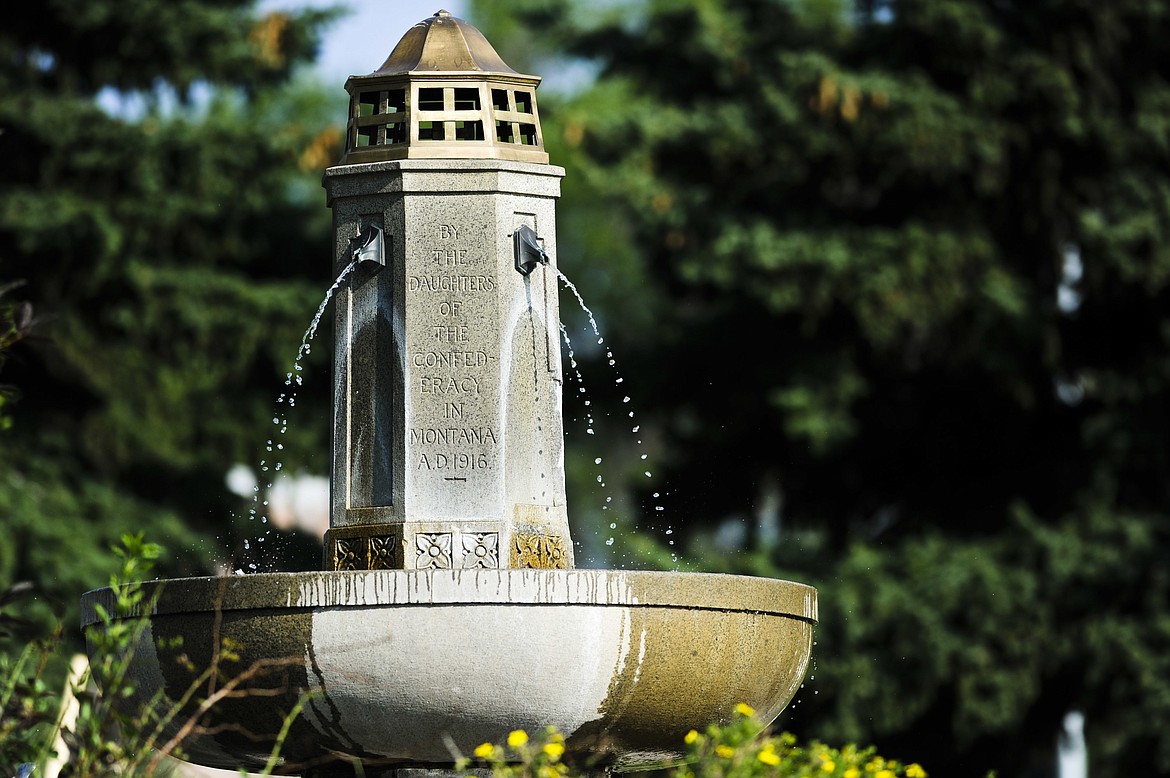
left=476, top=0, right=1170, bottom=776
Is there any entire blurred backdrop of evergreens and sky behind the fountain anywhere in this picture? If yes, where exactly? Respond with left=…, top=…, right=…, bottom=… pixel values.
left=0, top=0, right=1170, bottom=778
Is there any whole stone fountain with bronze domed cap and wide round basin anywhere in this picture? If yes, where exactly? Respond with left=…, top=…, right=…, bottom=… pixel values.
left=82, top=11, right=817, bottom=774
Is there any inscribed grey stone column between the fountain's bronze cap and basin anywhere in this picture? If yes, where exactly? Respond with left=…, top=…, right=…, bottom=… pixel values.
left=324, top=159, right=572, bottom=570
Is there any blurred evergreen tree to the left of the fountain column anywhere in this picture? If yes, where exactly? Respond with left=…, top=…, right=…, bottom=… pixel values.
left=0, top=0, right=344, bottom=627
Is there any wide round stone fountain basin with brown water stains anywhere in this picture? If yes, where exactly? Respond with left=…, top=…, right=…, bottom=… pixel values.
left=82, top=570, right=817, bottom=771
